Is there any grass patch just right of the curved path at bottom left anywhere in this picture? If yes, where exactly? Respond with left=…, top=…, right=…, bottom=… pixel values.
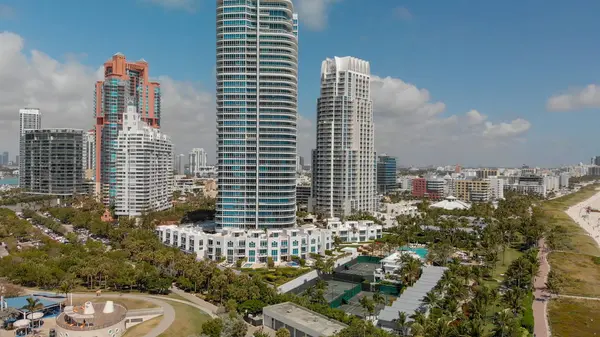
left=157, top=301, right=210, bottom=337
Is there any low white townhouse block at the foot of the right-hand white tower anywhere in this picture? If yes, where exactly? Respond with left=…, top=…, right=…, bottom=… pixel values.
left=327, top=218, right=383, bottom=242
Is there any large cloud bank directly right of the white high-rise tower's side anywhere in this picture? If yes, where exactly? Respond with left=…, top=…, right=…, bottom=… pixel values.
left=371, top=76, right=531, bottom=165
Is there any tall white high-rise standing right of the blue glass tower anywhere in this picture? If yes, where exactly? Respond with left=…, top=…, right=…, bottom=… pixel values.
left=312, top=57, right=377, bottom=217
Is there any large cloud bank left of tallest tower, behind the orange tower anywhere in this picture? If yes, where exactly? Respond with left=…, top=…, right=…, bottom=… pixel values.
left=0, top=32, right=216, bottom=159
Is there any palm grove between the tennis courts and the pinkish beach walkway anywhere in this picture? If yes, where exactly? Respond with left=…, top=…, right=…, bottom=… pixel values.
left=352, top=192, right=547, bottom=337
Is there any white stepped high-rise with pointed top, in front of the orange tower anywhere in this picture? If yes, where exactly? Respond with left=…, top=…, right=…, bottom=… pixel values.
left=115, top=102, right=173, bottom=216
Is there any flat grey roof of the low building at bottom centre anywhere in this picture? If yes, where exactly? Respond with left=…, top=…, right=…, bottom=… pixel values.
left=263, top=302, right=347, bottom=336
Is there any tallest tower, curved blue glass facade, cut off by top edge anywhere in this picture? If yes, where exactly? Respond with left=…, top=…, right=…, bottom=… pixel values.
left=216, top=0, right=298, bottom=228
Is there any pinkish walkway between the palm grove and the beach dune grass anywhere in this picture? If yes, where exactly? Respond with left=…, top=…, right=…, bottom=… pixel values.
left=533, top=238, right=551, bottom=337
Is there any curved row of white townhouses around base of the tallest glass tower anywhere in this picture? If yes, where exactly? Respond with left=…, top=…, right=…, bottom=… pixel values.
left=156, top=225, right=333, bottom=263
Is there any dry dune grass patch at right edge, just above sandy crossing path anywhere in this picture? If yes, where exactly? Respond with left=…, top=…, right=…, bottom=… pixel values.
left=548, top=252, right=600, bottom=296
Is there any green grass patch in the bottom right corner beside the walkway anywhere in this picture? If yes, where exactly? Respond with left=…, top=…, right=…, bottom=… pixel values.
left=548, top=298, right=600, bottom=337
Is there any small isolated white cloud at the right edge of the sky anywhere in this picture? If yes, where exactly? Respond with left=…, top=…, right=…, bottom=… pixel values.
left=546, top=84, right=600, bottom=111
